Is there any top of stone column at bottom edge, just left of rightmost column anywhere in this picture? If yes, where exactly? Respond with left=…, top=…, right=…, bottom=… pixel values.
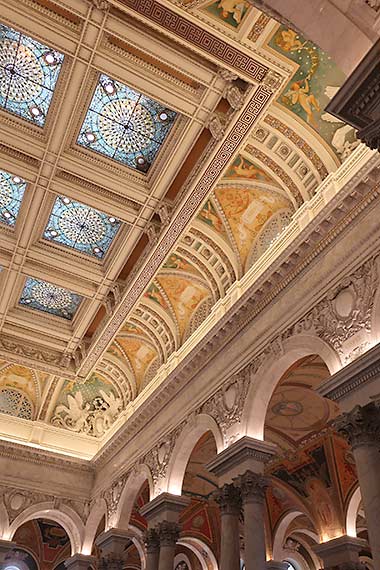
left=313, top=535, right=367, bottom=570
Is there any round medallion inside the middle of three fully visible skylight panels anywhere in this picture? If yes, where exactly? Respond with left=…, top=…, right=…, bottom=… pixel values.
left=58, top=206, right=107, bottom=245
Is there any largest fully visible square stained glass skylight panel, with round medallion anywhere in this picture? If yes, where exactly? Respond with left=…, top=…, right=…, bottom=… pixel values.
left=78, top=74, right=177, bottom=172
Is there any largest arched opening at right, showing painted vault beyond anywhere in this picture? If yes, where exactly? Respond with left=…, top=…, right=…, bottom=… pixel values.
left=264, top=354, right=355, bottom=570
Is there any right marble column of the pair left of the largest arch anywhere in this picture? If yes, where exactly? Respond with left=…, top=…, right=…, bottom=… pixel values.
left=234, top=470, right=269, bottom=570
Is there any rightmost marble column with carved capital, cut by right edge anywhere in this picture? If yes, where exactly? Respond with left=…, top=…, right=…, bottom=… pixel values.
left=335, top=401, right=380, bottom=570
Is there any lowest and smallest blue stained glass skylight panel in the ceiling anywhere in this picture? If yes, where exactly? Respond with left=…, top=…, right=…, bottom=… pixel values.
left=19, top=277, right=82, bottom=321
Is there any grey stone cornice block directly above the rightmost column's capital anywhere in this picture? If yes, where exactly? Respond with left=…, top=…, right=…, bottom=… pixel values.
left=317, top=344, right=380, bottom=402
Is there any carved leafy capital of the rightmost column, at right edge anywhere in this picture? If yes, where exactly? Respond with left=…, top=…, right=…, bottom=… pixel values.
left=334, top=400, right=380, bottom=448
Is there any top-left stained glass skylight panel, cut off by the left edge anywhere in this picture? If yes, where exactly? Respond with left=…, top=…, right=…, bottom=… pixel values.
left=0, top=24, right=63, bottom=127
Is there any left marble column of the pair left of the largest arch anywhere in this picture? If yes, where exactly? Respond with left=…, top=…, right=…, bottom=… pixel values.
left=214, top=483, right=240, bottom=570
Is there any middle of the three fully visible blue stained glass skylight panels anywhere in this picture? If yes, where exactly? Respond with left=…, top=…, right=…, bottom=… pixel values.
left=44, top=196, right=121, bottom=258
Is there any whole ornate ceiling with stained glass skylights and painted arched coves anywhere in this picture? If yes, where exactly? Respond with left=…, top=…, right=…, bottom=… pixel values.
left=0, top=0, right=357, bottom=453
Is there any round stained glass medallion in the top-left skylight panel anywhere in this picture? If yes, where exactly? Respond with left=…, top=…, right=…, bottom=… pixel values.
left=0, top=38, right=44, bottom=102
